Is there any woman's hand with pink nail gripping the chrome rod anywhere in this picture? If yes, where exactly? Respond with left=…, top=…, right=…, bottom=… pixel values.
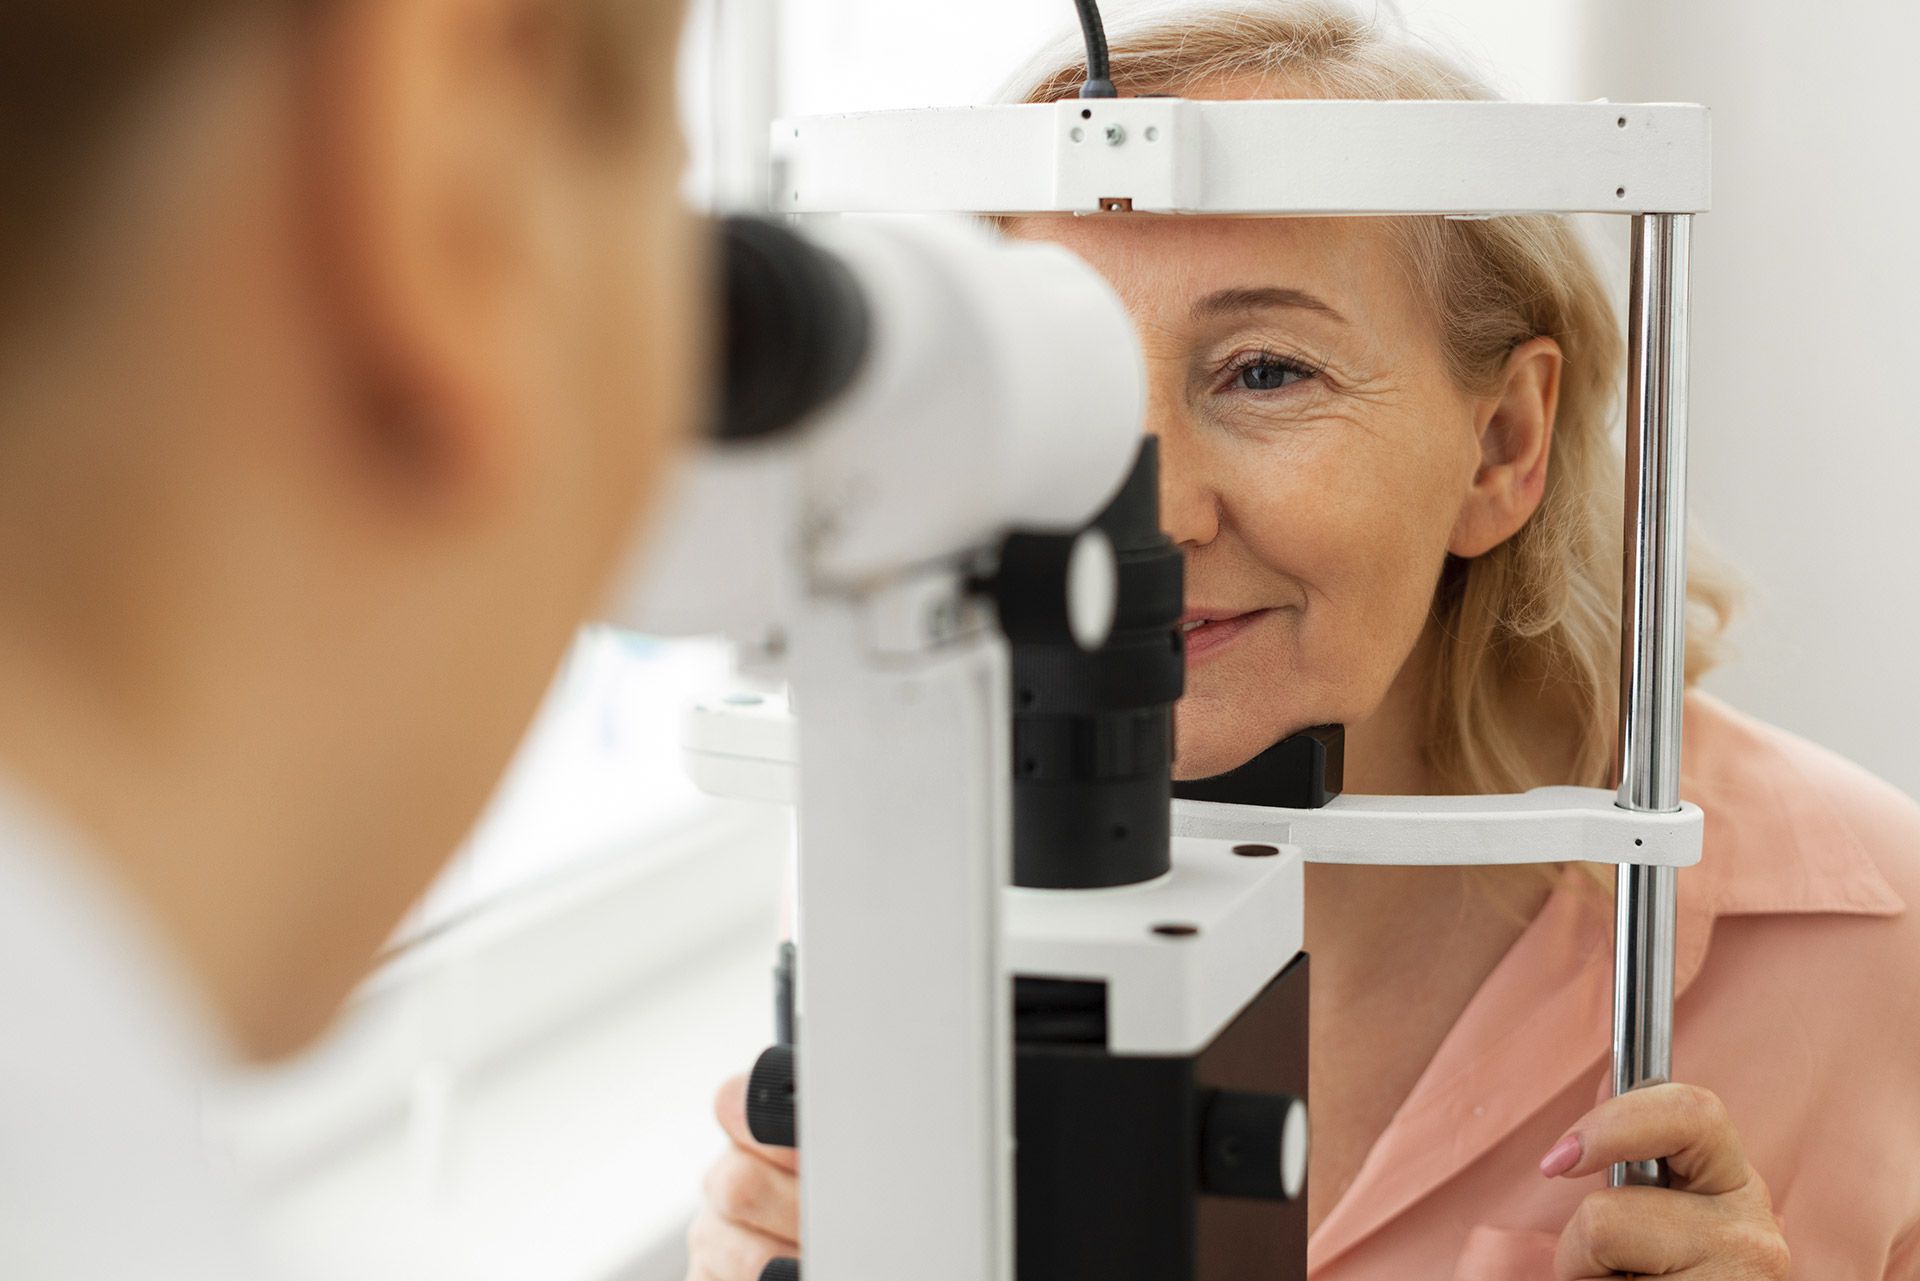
left=1540, top=1085, right=1788, bottom=1281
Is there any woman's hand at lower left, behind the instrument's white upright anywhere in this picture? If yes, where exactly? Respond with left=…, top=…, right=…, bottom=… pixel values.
left=687, top=1076, right=801, bottom=1281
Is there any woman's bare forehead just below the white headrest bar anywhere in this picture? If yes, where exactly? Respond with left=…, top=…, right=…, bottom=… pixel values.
left=1008, top=215, right=1407, bottom=319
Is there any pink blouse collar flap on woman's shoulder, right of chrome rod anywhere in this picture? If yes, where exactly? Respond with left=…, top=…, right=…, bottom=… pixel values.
left=1682, top=693, right=1920, bottom=921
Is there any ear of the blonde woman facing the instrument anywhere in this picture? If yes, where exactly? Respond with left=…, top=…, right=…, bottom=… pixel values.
left=1448, top=338, right=1565, bottom=559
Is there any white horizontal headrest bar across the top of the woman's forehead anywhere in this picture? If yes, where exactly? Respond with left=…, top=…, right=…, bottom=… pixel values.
left=772, top=98, right=1711, bottom=217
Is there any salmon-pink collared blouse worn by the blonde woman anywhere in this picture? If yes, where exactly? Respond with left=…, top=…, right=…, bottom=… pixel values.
left=1308, top=695, right=1920, bottom=1281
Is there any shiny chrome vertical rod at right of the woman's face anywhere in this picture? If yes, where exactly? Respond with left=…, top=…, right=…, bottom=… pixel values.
left=1609, top=213, right=1692, bottom=1187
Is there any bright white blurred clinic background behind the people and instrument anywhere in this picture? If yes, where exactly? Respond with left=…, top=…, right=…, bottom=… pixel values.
left=209, top=0, right=1920, bottom=1281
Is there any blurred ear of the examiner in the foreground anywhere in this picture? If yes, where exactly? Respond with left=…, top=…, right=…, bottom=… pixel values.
left=303, top=0, right=570, bottom=507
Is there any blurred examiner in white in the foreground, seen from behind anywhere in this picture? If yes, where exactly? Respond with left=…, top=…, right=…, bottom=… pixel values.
left=0, top=0, right=707, bottom=1281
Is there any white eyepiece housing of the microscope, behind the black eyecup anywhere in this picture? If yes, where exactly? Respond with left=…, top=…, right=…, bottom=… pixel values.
left=612, top=219, right=1144, bottom=641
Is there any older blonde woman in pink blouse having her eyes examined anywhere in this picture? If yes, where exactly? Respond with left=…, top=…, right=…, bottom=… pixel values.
left=691, top=0, right=1920, bottom=1281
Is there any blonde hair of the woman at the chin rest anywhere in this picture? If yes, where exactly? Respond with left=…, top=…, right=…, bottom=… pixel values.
left=1004, top=0, right=1734, bottom=793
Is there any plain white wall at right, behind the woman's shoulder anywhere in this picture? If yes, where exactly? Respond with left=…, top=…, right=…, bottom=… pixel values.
left=1580, top=0, right=1920, bottom=795
